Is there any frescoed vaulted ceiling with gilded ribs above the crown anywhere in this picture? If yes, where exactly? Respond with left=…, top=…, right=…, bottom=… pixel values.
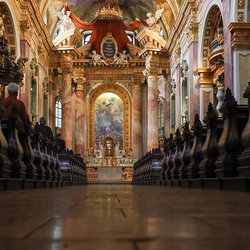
left=37, top=0, right=180, bottom=38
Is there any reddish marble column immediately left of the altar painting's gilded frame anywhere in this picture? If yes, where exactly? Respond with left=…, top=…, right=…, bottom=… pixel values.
left=75, top=78, right=87, bottom=157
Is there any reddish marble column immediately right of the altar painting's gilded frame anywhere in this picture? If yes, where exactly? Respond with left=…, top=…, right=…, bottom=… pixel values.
left=132, top=79, right=143, bottom=159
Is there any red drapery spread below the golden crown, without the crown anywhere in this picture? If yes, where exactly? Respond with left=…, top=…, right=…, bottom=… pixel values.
left=65, top=6, right=146, bottom=54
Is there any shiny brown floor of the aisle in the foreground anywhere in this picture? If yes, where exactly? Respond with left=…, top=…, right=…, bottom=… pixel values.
left=0, top=185, right=250, bottom=250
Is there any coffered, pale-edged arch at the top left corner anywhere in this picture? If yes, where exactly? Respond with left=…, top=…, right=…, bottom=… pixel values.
left=0, top=0, right=20, bottom=58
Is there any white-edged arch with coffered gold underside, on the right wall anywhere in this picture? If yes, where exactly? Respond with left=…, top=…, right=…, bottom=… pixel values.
left=198, top=0, right=223, bottom=68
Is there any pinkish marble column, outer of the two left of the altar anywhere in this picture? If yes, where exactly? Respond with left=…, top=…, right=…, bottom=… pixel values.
left=62, top=68, right=72, bottom=150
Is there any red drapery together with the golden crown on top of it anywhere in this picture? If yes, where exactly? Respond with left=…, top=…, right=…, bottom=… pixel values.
left=65, top=2, right=148, bottom=54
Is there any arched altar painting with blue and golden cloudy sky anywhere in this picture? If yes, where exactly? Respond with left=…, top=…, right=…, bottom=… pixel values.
left=95, top=93, right=123, bottom=148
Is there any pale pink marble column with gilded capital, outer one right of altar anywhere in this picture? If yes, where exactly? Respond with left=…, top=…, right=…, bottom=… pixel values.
left=144, top=68, right=162, bottom=151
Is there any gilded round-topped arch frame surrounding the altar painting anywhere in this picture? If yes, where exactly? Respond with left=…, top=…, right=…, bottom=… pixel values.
left=87, top=82, right=132, bottom=152
